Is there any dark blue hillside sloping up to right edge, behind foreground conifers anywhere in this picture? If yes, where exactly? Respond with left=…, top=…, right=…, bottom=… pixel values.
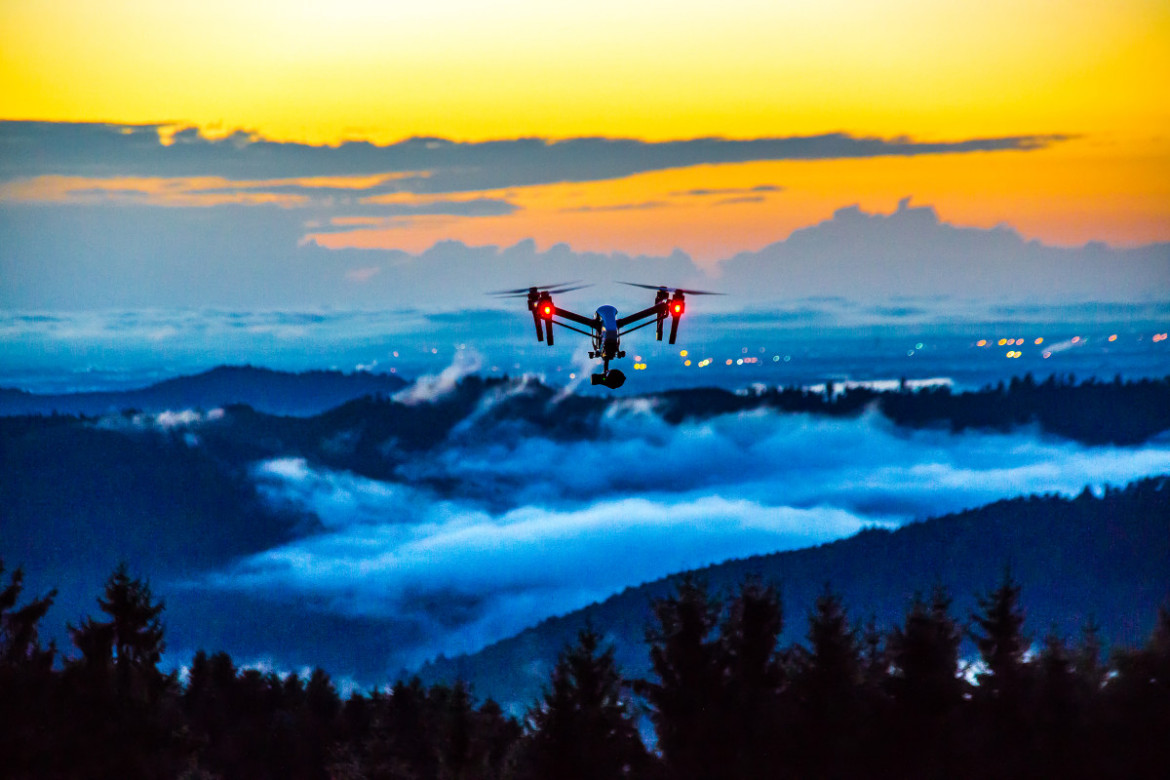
left=420, top=476, right=1170, bottom=706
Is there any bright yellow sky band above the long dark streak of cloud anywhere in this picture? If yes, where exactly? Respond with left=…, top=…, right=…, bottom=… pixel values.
left=0, top=0, right=1170, bottom=143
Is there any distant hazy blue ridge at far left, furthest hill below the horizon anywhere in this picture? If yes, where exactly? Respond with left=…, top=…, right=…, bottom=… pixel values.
left=0, top=366, right=406, bottom=415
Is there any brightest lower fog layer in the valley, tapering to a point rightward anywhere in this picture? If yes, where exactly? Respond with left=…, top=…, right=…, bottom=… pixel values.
left=209, top=461, right=884, bottom=665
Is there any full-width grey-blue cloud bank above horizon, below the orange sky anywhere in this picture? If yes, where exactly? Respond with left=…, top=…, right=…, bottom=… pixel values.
left=0, top=185, right=1170, bottom=315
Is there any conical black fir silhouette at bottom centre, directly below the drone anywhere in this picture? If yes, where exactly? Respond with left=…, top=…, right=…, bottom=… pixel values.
left=519, top=628, right=649, bottom=780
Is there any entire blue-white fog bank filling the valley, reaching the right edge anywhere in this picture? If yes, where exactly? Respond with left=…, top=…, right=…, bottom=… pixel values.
left=196, top=402, right=1170, bottom=668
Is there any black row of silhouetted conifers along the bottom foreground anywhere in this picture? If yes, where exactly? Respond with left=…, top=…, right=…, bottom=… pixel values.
left=0, top=566, right=1170, bottom=780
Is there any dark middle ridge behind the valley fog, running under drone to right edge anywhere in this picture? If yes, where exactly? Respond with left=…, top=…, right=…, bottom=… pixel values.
left=180, top=375, right=1170, bottom=489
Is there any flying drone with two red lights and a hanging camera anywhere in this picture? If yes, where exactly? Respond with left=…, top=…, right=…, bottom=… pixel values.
left=489, top=282, right=723, bottom=389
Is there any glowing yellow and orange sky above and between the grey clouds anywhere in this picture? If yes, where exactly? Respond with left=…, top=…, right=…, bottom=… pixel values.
left=0, top=0, right=1170, bottom=262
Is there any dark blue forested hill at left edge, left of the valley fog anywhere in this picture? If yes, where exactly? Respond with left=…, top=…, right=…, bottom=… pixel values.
left=0, top=416, right=317, bottom=654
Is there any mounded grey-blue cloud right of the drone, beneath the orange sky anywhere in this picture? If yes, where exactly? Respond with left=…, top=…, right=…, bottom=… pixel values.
left=717, top=198, right=1170, bottom=305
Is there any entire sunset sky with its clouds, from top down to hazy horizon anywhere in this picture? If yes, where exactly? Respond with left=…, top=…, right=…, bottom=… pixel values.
left=0, top=0, right=1170, bottom=310
